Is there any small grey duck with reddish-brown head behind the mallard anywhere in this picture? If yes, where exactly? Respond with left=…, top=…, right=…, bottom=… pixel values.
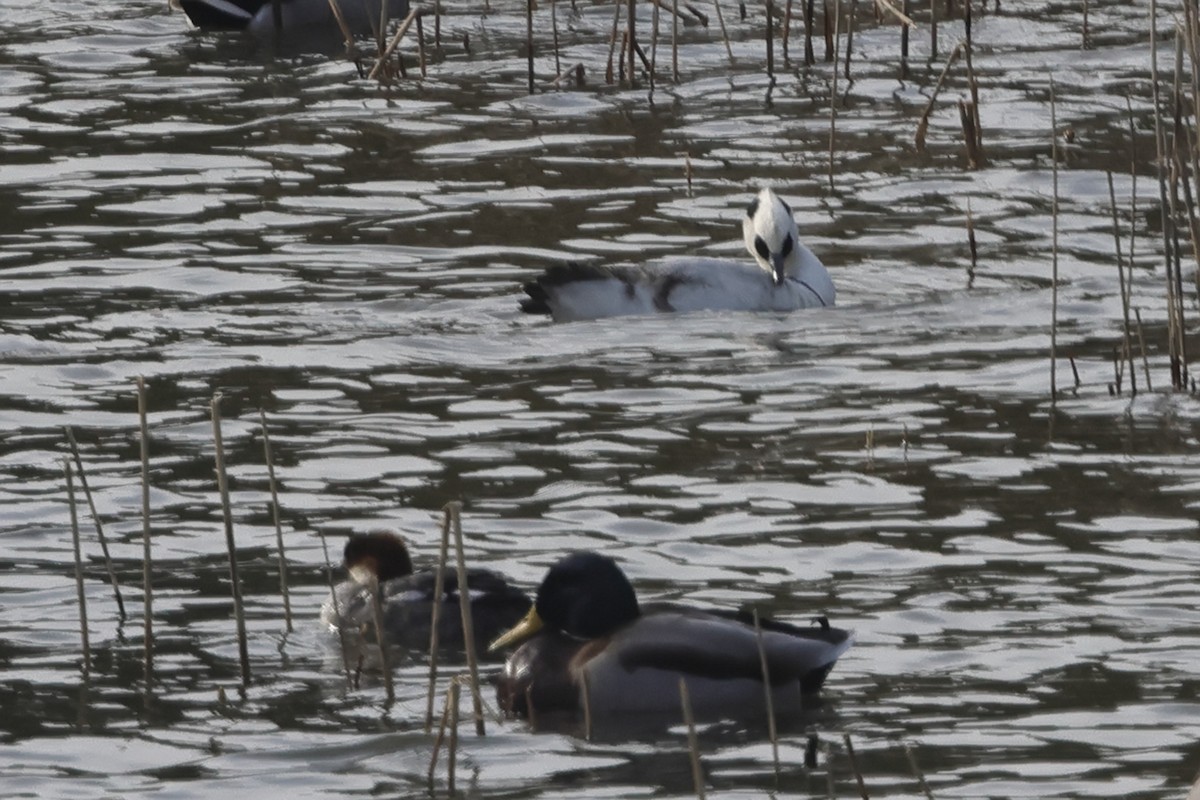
left=320, top=530, right=530, bottom=655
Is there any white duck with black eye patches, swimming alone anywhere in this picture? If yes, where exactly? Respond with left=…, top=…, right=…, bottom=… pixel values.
left=521, top=188, right=836, bottom=321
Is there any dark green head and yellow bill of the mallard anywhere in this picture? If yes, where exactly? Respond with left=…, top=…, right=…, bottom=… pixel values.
left=488, top=552, right=640, bottom=650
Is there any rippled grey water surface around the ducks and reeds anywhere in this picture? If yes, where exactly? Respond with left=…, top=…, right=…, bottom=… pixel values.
left=0, top=0, right=1200, bottom=798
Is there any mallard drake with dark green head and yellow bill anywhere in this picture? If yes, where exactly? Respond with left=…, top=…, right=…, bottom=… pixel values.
left=491, top=552, right=853, bottom=721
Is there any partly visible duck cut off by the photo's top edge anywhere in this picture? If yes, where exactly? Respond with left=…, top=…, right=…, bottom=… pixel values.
left=178, top=0, right=408, bottom=43
